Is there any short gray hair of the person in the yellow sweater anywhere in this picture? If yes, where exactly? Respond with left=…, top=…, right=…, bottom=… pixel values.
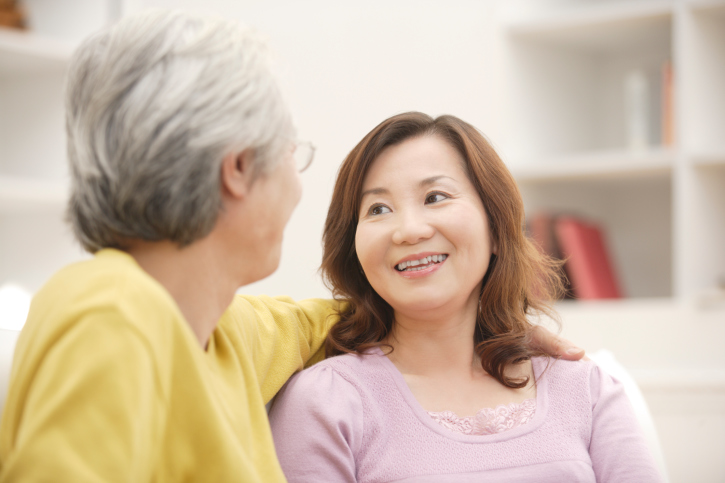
left=66, top=11, right=295, bottom=252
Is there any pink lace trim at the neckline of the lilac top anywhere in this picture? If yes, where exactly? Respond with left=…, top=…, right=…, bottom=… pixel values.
left=428, top=399, right=536, bottom=435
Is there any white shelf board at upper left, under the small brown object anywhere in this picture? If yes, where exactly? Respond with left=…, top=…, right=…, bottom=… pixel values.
left=0, top=27, right=74, bottom=77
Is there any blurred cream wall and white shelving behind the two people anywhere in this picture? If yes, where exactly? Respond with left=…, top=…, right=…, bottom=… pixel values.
left=0, top=0, right=725, bottom=482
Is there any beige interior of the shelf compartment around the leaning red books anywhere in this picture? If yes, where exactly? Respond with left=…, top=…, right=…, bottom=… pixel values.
left=519, top=175, right=673, bottom=298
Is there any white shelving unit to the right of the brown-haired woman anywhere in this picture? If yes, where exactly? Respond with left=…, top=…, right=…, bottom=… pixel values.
left=498, top=0, right=725, bottom=482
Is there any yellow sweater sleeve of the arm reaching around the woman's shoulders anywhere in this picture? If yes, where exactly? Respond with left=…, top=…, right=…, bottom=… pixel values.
left=222, top=295, right=340, bottom=403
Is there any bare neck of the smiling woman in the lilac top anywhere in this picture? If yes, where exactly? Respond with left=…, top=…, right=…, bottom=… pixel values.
left=386, top=300, right=481, bottom=376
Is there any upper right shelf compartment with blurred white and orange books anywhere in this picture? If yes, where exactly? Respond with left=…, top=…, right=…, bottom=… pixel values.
left=501, top=2, right=676, bottom=158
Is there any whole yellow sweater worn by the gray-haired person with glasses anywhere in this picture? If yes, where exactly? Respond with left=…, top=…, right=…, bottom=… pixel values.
left=0, top=250, right=336, bottom=483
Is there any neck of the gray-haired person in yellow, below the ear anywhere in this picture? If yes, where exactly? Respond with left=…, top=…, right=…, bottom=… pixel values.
left=127, top=236, right=240, bottom=348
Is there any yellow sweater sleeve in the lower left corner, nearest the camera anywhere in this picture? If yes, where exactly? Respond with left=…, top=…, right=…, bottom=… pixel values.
left=2, top=311, right=164, bottom=483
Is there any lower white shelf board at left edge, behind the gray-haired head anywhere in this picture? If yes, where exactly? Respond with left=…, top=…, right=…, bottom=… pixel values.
left=0, top=175, right=68, bottom=213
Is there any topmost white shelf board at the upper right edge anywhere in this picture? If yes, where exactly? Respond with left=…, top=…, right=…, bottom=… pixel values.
left=504, top=0, right=674, bottom=51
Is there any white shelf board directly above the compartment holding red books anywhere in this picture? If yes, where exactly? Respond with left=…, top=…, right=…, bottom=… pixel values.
left=510, top=149, right=675, bottom=182
